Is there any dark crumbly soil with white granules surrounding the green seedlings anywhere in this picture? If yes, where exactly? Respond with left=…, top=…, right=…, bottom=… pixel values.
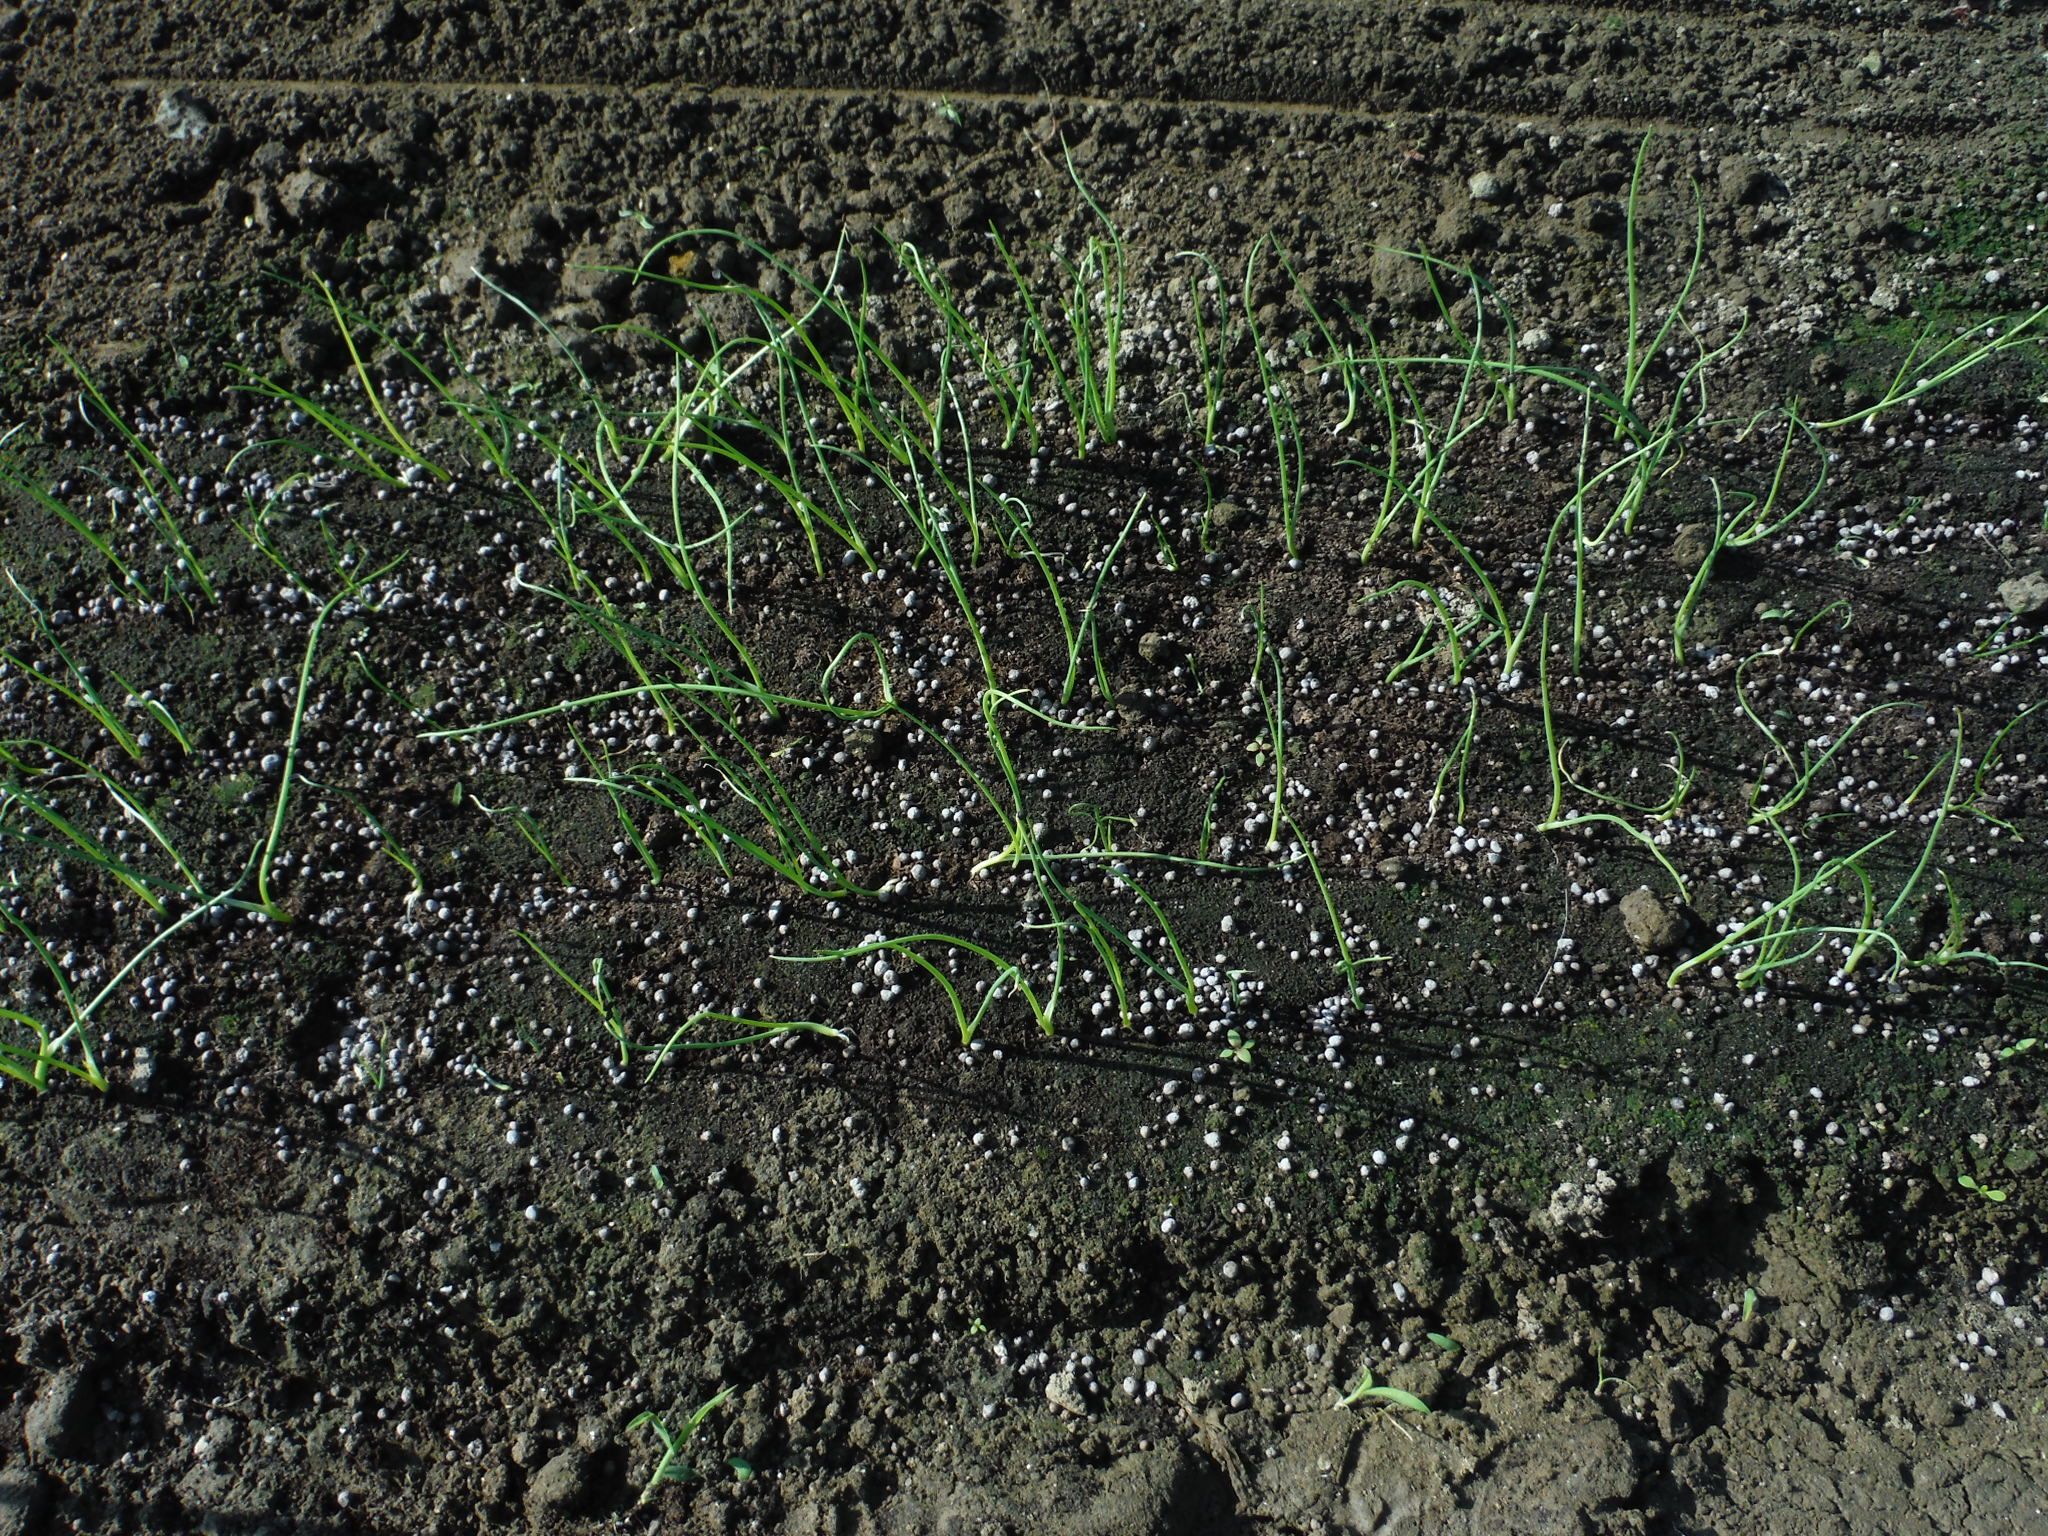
left=0, top=0, right=2048, bottom=1536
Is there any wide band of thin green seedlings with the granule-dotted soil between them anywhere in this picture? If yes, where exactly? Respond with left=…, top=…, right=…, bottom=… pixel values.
left=0, top=138, right=2048, bottom=1122
